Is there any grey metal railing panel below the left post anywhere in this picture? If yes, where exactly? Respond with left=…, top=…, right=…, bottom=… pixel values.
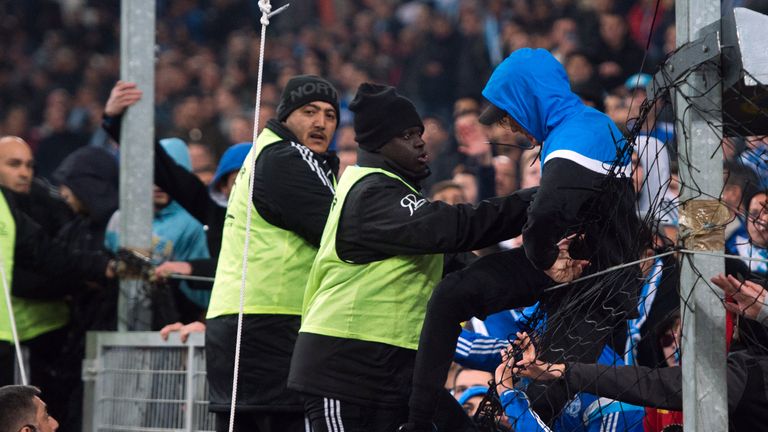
left=83, top=332, right=215, bottom=432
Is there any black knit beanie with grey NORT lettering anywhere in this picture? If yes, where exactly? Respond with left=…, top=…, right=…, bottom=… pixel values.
left=277, top=75, right=339, bottom=122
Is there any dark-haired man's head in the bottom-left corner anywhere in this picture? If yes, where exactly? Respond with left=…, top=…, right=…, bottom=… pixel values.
left=0, top=385, right=59, bottom=432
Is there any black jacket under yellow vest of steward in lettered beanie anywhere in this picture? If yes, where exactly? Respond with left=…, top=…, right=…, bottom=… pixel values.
left=206, top=119, right=339, bottom=411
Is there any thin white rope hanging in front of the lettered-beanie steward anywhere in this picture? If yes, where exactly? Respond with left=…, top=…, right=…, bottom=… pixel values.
left=229, top=0, right=288, bottom=432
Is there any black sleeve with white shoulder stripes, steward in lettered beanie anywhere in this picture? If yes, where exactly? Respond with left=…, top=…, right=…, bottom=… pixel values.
left=253, top=142, right=334, bottom=247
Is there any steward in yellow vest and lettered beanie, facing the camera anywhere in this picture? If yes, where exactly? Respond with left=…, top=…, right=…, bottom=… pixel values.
left=206, top=75, right=339, bottom=432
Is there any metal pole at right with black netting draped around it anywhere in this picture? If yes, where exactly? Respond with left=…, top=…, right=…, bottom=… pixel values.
left=675, top=0, right=728, bottom=432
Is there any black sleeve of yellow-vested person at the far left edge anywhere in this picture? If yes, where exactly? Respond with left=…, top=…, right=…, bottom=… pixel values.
left=3, top=190, right=109, bottom=280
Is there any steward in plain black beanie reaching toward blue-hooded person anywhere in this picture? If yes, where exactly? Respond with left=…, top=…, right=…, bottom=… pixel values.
left=288, top=83, right=544, bottom=432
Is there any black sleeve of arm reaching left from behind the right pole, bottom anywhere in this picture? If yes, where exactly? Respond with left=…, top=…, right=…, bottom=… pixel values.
left=565, top=363, right=683, bottom=411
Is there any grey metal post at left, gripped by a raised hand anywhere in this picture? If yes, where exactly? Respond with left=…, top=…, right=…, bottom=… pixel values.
left=118, top=0, right=155, bottom=331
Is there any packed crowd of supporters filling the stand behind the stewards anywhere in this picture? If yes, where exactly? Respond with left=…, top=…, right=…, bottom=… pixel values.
left=0, top=0, right=768, bottom=431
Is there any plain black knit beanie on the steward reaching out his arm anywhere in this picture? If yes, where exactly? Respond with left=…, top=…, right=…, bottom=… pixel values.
left=349, top=83, right=424, bottom=151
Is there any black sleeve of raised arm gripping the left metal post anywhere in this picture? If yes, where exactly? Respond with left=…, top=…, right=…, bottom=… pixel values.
left=101, top=111, right=218, bottom=225
